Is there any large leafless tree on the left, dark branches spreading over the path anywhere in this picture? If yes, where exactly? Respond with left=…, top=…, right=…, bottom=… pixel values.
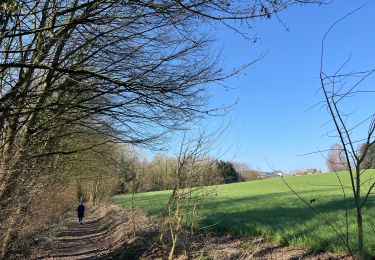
left=0, top=0, right=323, bottom=256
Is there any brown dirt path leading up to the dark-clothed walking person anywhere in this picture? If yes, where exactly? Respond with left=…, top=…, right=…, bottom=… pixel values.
left=37, top=206, right=150, bottom=260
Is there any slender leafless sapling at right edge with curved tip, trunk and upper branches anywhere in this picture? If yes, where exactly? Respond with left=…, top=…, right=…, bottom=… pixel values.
left=320, top=9, right=375, bottom=259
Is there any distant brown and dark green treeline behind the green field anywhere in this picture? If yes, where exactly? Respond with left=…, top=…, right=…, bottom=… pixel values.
left=118, top=155, right=262, bottom=193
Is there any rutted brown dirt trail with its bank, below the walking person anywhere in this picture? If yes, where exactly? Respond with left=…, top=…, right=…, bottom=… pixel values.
left=37, top=205, right=153, bottom=260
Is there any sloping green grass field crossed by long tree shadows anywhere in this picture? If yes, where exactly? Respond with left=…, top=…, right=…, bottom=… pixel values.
left=113, top=170, right=375, bottom=254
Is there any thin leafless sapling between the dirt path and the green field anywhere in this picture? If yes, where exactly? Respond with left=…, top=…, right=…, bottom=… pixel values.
left=160, top=131, right=217, bottom=259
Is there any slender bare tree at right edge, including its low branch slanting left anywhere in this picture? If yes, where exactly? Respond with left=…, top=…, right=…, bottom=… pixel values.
left=280, top=6, right=375, bottom=259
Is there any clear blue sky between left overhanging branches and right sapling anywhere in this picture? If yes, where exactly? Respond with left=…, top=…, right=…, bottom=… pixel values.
left=149, top=0, right=375, bottom=171
